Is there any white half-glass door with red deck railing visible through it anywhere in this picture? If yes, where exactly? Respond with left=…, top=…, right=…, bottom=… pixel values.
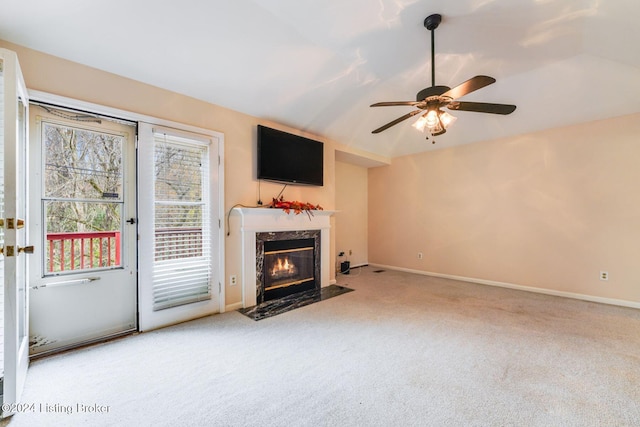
left=30, top=103, right=137, bottom=355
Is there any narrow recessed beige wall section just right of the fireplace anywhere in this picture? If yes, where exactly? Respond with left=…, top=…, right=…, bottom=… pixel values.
left=335, top=161, right=369, bottom=271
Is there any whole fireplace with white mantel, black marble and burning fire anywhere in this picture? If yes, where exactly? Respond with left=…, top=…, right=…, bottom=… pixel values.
left=228, top=208, right=335, bottom=308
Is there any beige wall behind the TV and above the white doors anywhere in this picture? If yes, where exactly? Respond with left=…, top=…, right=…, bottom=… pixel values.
left=0, top=40, right=337, bottom=305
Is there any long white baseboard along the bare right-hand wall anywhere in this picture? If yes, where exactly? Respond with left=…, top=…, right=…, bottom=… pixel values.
left=369, top=264, right=640, bottom=309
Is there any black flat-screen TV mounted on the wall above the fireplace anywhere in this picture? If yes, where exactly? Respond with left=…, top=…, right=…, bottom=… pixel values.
left=258, top=125, right=324, bottom=186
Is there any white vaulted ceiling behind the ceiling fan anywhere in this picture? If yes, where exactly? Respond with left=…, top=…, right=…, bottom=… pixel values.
left=0, top=0, right=640, bottom=157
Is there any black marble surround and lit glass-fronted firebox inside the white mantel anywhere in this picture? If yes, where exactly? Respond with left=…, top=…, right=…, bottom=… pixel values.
left=256, top=230, right=320, bottom=304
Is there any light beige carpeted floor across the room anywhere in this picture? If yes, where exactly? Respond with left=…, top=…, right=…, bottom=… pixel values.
left=3, top=268, right=640, bottom=427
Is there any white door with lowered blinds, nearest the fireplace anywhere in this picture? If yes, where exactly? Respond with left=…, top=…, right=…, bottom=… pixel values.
left=138, top=123, right=224, bottom=331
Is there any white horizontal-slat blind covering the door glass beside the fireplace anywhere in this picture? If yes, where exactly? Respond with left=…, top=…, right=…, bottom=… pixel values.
left=153, top=133, right=211, bottom=311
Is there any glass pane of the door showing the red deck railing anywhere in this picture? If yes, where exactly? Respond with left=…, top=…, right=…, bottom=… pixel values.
left=42, top=122, right=127, bottom=275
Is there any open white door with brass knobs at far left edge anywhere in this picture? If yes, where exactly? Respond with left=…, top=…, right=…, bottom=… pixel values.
left=0, top=49, right=33, bottom=417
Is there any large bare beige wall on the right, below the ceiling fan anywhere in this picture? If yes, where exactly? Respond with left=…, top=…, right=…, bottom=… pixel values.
left=369, top=114, right=640, bottom=302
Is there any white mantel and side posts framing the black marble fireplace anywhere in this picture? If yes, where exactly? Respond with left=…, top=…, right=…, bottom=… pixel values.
left=232, top=208, right=334, bottom=308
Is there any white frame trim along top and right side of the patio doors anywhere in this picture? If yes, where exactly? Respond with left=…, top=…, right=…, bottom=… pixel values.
left=29, top=90, right=225, bottom=328
